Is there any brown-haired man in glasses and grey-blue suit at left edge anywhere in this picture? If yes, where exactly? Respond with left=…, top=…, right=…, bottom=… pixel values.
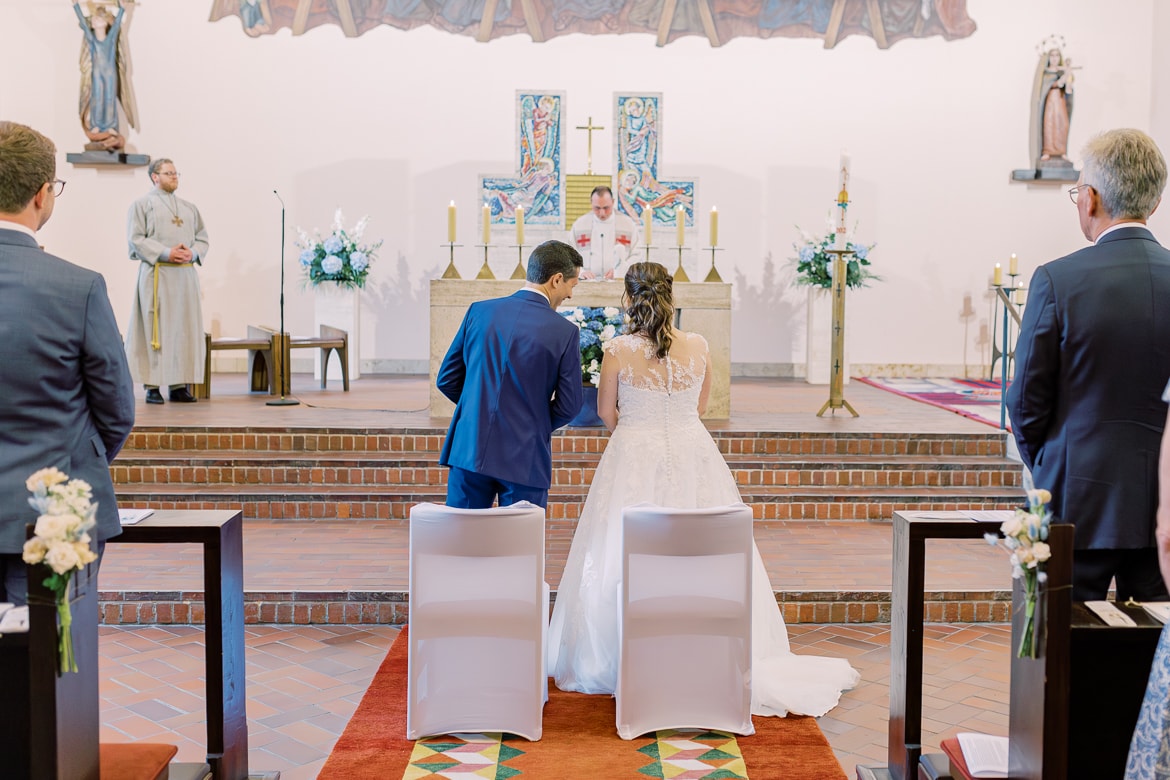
left=0, top=122, right=135, bottom=603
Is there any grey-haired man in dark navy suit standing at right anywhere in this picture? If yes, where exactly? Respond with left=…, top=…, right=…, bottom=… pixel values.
left=1007, top=130, right=1170, bottom=601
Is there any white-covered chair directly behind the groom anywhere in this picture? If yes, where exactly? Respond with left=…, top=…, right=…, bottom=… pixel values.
left=406, top=502, right=549, bottom=740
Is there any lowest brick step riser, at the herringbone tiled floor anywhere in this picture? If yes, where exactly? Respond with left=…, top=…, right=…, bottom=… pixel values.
left=97, top=591, right=1012, bottom=626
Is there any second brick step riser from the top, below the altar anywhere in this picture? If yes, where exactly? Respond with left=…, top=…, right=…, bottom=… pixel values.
left=111, top=450, right=1020, bottom=490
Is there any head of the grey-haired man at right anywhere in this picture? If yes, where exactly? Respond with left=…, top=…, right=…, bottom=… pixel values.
left=1081, top=127, right=1166, bottom=220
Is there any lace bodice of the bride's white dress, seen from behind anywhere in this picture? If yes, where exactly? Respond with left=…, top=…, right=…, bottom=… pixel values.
left=604, top=332, right=707, bottom=426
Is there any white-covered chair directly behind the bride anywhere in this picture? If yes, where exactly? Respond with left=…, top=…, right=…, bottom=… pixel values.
left=617, top=504, right=755, bottom=739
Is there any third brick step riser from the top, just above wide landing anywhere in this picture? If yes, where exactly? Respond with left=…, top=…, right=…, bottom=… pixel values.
left=118, top=484, right=1020, bottom=522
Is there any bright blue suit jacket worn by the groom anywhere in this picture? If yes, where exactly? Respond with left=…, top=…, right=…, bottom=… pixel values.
left=436, top=290, right=581, bottom=489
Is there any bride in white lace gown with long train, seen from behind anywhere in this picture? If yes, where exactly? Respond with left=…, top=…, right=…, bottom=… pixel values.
left=549, top=263, right=859, bottom=717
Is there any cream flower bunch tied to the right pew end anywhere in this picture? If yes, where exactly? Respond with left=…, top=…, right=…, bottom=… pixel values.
left=984, top=489, right=1052, bottom=658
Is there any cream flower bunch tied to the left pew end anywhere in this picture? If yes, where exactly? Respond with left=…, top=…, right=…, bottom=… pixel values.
left=21, top=469, right=97, bottom=675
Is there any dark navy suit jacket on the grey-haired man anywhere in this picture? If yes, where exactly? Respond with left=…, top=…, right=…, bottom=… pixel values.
left=1007, top=227, right=1170, bottom=550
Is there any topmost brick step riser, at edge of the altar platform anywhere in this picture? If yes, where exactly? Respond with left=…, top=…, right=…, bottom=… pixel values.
left=123, top=426, right=1005, bottom=457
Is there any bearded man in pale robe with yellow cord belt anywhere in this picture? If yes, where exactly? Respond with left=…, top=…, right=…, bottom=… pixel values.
left=126, top=158, right=207, bottom=403
